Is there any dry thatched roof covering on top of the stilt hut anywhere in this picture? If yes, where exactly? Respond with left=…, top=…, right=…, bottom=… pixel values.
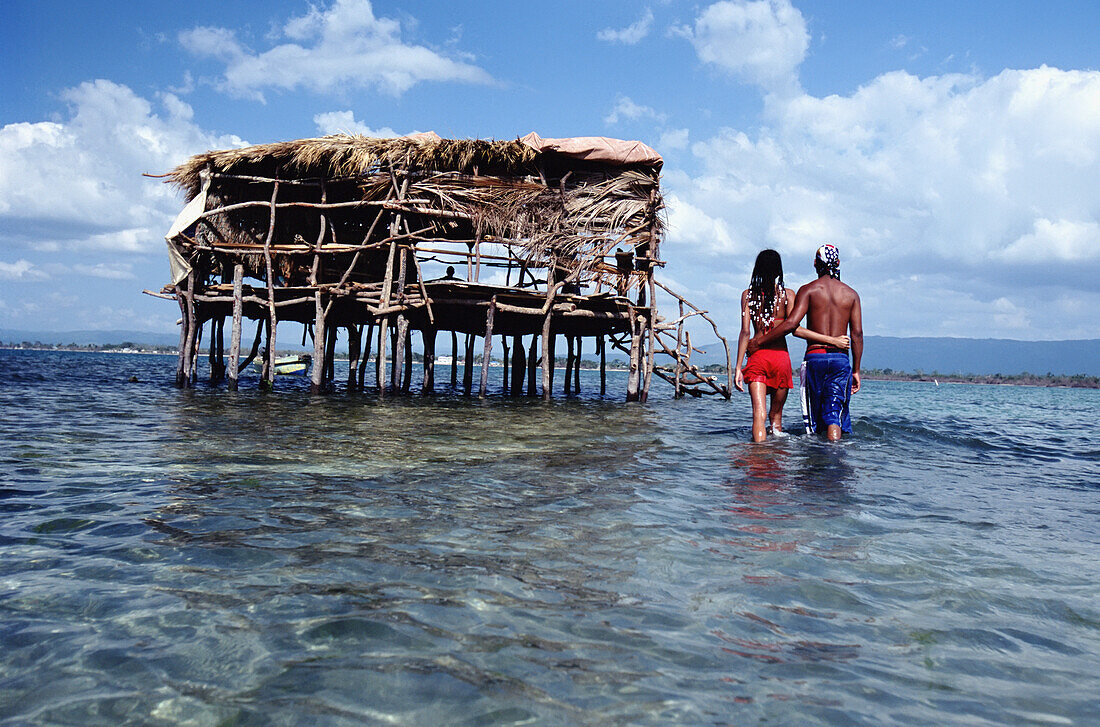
left=167, top=132, right=661, bottom=199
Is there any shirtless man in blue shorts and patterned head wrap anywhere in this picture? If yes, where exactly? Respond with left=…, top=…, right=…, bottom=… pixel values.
left=748, top=244, right=864, bottom=442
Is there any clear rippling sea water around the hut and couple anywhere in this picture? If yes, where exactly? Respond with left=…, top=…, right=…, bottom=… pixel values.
left=0, top=351, right=1100, bottom=725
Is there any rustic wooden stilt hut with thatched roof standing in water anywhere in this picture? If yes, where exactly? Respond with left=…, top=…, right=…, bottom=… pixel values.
left=146, top=133, right=732, bottom=401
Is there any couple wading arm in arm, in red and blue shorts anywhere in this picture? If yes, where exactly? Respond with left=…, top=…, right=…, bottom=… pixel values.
left=735, top=245, right=864, bottom=442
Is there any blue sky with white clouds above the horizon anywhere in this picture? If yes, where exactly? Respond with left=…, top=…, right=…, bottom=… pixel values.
left=0, top=0, right=1100, bottom=340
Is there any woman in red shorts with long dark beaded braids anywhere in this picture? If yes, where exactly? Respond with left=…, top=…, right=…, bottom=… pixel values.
left=734, top=250, right=848, bottom=442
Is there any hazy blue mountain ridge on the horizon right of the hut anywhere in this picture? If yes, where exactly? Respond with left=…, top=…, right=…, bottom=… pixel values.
left=692, top=335, right=1100, bottom=376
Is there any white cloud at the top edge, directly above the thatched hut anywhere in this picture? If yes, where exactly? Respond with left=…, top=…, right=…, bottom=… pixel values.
left=179, top=0, right=492, bottom=100
